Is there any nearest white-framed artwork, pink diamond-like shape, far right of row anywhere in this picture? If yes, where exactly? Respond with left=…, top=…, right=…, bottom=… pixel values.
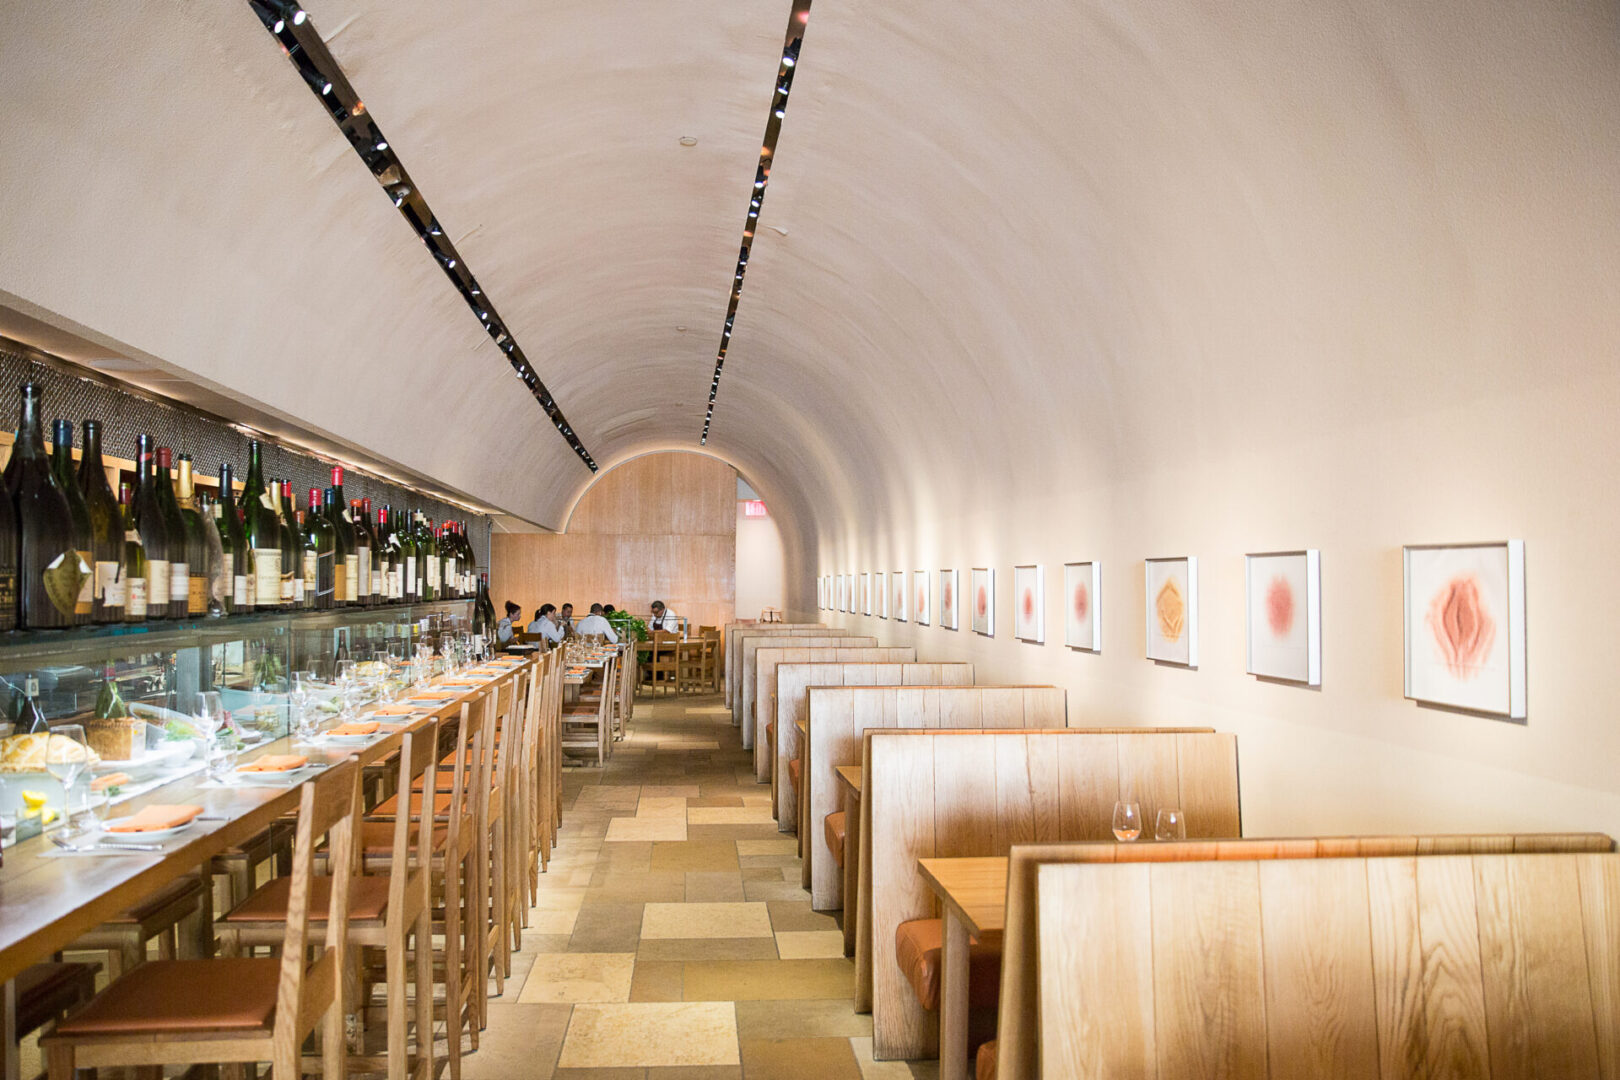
left=1401, top=541, right=1526, bottom=721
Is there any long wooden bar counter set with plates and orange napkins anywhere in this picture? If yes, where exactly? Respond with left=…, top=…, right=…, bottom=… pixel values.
left=0, top=659, right=535, bottom=983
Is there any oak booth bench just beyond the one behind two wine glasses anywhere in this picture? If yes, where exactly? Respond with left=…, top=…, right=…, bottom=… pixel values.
left=795, top=685, right=1062, bottom=906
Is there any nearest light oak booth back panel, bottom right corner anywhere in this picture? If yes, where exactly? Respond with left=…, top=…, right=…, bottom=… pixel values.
left=1037, top=853, right=1620, bottom=1080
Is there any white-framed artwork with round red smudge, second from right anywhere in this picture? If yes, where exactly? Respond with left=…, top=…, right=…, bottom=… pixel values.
left=1243, top=547, right=1322, bottom=687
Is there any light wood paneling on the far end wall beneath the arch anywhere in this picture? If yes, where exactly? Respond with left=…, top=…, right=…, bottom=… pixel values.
left=489, top=453, right=737, bottom=627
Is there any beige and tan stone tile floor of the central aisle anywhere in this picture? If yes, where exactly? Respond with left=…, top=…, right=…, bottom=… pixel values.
left=463, top=696, right=936, bottom=1080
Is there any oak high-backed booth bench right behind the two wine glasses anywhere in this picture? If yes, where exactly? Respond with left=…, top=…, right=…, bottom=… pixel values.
left=861, top=722, right=1243, bottom=1059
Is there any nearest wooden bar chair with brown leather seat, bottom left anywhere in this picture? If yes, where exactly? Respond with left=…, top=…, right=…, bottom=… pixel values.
left=41, top=759, right=360, bottom=1080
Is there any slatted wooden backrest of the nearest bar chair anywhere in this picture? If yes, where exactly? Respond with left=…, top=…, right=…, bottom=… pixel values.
left=272, top=758, right=361, bottom=1077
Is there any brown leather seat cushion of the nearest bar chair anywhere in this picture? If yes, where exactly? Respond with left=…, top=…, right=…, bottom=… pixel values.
left=57, top=957, right=282, bottom=1038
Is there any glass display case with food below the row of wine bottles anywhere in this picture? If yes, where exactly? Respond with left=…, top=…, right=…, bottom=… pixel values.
left=0, top=601, right=473, bottom=818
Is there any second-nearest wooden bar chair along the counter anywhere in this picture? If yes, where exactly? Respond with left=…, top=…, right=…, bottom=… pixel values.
left=219, top=721, right=439, bottom=1080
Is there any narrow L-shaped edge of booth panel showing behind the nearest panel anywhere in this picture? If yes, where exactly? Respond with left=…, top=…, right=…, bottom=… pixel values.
left=996, top=832, right=1615, bottom=1077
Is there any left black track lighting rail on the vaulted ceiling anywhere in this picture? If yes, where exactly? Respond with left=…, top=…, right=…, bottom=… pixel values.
left=236, top=0, right=596, bottom=473
